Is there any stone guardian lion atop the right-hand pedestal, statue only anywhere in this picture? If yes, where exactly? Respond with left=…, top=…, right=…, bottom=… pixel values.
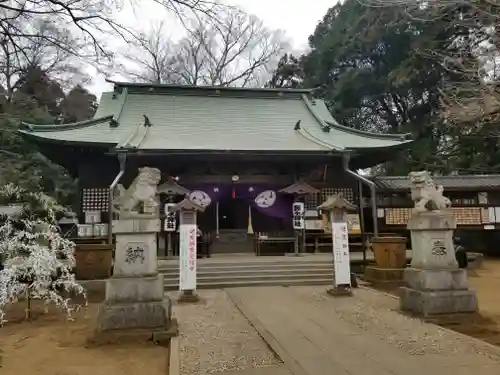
left=409, top=171, right=451, bottom=212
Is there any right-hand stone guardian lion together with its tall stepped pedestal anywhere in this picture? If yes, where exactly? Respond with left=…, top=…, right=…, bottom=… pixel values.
left=400, top=171, right=478, bottom=316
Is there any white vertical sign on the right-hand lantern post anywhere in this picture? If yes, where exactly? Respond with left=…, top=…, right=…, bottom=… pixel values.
left=332, top=222, right=351, bottom=286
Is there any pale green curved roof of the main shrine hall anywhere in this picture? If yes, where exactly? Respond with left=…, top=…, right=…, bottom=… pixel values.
left=22, top=84, right=411, bottom=152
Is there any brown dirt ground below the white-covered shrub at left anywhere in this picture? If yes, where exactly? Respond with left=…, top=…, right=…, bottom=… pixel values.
left=0, top=303, right=168, bottom=375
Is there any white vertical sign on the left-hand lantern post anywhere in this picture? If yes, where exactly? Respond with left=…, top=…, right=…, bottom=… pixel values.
left=179, top=224, right=197, bottom=290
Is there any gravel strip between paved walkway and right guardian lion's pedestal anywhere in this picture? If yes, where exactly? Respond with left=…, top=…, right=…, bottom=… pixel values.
left=294, top=287, right=500, bottom=361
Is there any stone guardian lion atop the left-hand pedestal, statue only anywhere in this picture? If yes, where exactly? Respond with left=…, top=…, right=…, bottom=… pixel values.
left=113, top=167, right=161, bottom=219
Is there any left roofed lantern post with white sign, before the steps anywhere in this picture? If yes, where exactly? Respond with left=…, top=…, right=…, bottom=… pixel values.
left=169, top=198, right=205, bottom=302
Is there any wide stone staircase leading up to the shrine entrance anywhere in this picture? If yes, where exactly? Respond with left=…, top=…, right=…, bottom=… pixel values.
left=158, top=255, right=340, bottom=290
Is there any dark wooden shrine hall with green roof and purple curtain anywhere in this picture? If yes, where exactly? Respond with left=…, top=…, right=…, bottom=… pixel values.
left=20, top=82, right=412, bottom=255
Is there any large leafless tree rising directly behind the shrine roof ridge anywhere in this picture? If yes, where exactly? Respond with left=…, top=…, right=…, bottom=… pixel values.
left=125, top=8, right=287, bottom=87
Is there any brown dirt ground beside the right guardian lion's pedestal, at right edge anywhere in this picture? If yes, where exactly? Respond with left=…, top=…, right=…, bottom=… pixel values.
left=370, top=259, right=500, bottom=346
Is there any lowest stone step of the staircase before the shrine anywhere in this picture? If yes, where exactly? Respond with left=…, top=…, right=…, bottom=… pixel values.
left=165, top=278, right=332, bottom=290
